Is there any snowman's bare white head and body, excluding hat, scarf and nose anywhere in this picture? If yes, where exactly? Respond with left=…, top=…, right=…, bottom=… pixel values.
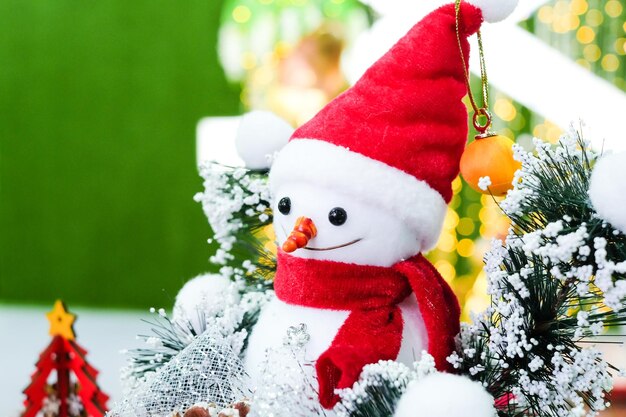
left=245, top=182, right=427, bottom=384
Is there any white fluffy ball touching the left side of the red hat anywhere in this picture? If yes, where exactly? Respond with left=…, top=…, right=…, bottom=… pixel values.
left=235, top=110, right=294, bottom=169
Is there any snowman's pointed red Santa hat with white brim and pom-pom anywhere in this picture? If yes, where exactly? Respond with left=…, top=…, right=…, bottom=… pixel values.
left=270, top=0, right=517, bottom=250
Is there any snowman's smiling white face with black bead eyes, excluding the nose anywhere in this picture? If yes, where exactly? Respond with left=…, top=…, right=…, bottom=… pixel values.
left=273, top=183, right=420, bottom=266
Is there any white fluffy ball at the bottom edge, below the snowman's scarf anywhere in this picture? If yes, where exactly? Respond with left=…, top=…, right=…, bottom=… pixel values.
left=393, top=373, right=496, bottom=417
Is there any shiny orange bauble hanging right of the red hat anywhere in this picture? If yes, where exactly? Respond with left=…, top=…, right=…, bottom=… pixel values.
left=461, top=134, right=522, bottom=197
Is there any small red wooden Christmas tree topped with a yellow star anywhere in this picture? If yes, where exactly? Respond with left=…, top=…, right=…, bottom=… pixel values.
left=22, top=300, right=109, bottom=417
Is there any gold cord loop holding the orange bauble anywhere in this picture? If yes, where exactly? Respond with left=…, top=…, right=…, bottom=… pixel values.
left=454, top=0, right=492, bottom=137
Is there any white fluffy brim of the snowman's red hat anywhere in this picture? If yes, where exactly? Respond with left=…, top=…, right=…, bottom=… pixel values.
left=270, top=139, right=447, bottom=251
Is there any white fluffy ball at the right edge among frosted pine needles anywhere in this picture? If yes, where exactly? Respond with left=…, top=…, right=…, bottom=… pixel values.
left=589, top=152, right=626, bottom=233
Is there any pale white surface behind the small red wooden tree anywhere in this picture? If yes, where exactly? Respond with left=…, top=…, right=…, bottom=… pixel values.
left=0, top=303, right=149, bottom=417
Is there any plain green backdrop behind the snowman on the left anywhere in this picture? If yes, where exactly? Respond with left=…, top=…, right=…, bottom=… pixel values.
left=0, top=0, right=239, bottom=308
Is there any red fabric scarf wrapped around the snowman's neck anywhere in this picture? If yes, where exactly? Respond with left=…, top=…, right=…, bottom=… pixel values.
left=274, top=251, right=460, bottom=408
